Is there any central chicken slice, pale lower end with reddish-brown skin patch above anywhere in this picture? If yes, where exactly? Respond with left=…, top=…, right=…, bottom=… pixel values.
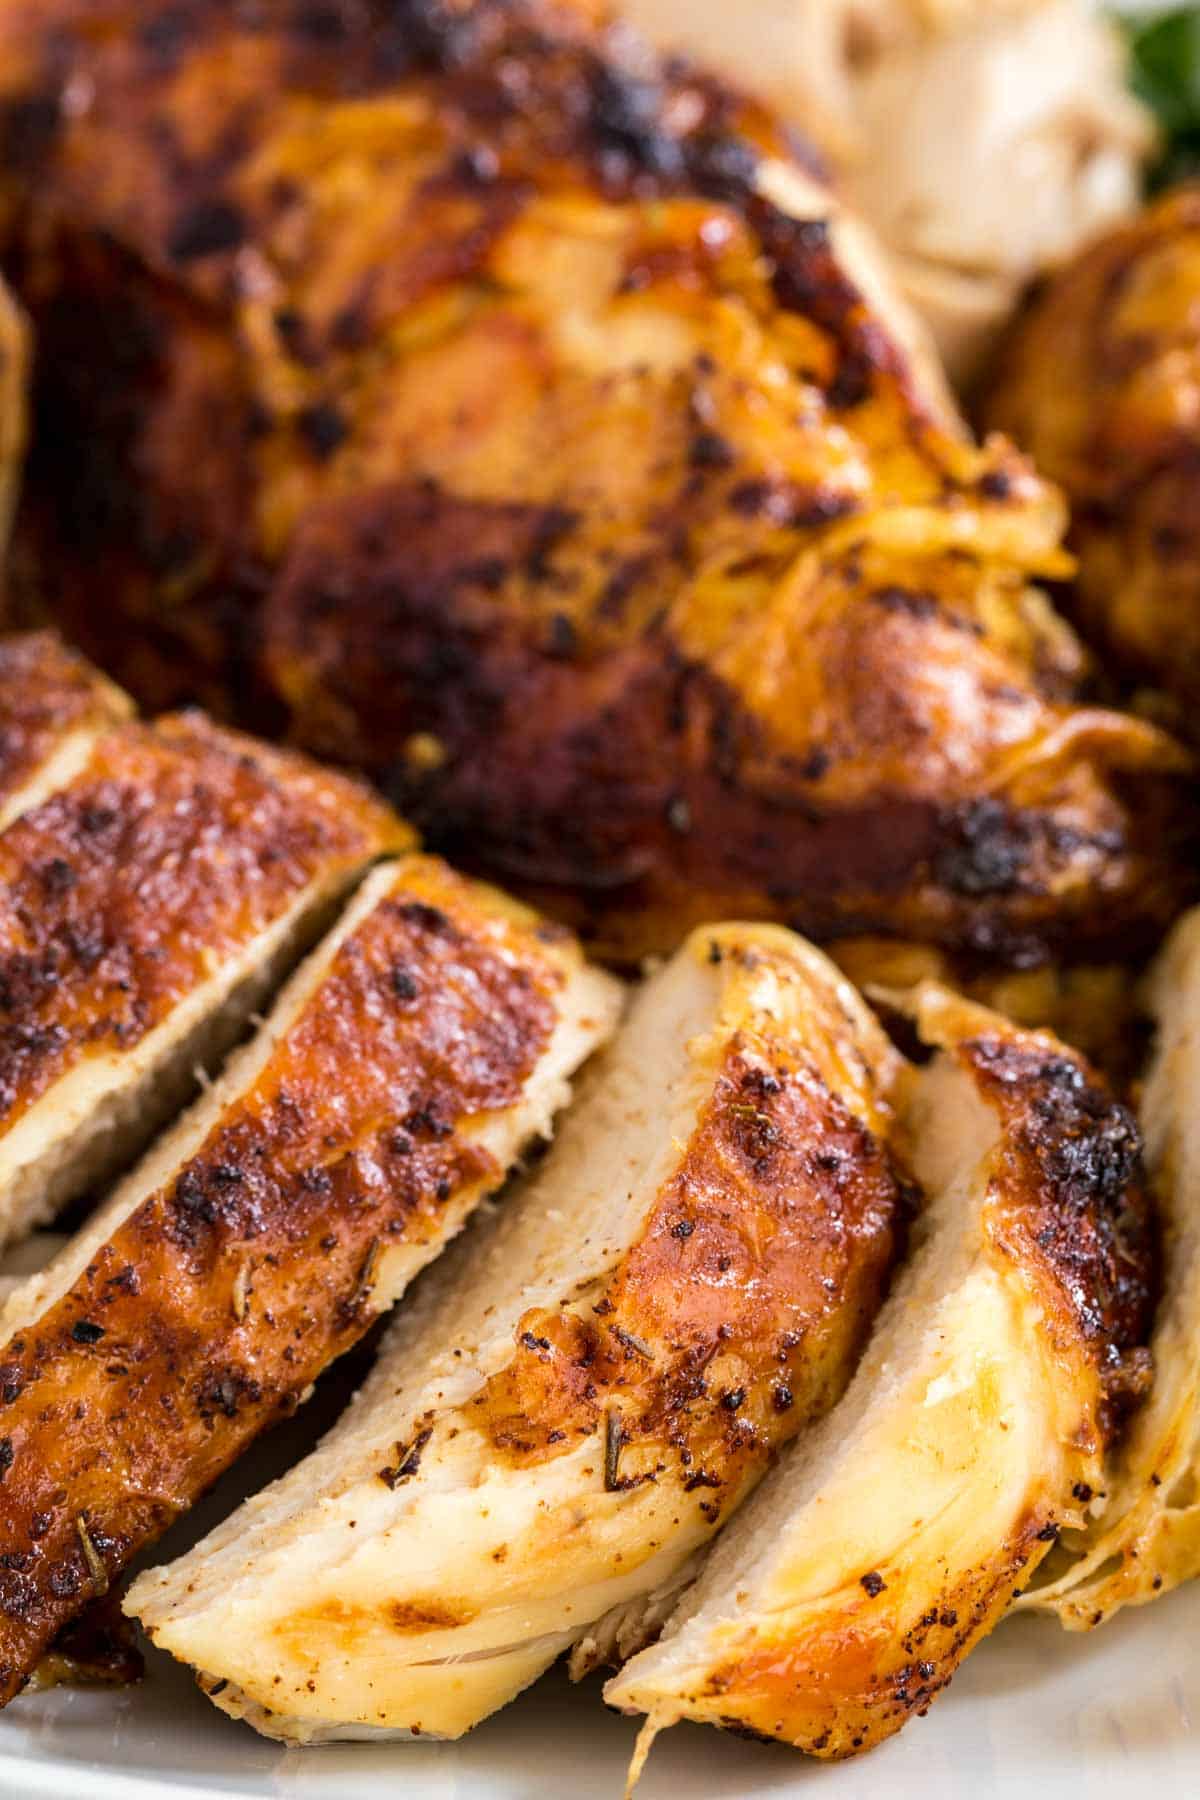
left=128, top=925, right=905, bottom=1741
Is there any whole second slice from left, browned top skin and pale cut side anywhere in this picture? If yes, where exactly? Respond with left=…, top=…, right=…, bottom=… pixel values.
left=0, top=715, right=412, bottom=1244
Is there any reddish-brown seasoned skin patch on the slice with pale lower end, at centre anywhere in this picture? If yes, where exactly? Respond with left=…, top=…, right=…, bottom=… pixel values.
left=466, top=1022, right=907, bottom=1526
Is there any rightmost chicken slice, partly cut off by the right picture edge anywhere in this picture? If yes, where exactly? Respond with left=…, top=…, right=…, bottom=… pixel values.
left=1020, top=913, right=1200, bottom=1631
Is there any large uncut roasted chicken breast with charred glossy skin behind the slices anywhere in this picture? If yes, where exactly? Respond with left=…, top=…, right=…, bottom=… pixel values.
left=0, top=0, right=1180, bottom=961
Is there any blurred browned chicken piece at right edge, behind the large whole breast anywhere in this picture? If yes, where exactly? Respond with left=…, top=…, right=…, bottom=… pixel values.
left=986, top=185, right=1200, bottom=734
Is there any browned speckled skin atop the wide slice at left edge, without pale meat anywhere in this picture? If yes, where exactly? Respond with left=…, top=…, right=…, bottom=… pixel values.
left=0, top=715, right=402, bottom=1129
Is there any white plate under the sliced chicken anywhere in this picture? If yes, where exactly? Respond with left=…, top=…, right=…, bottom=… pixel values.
left=0, top=1588, right=1200, bottom=1800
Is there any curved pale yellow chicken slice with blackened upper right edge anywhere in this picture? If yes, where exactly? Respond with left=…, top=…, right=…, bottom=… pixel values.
left=606, top=986, right=1153, bottom=1773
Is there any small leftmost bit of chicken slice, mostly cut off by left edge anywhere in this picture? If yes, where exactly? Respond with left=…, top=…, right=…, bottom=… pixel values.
left=0, top=633, right=133, bottom=830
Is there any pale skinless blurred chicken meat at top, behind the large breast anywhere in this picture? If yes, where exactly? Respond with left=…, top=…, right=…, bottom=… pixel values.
left=622, top=0, right=1155, bottom=382
